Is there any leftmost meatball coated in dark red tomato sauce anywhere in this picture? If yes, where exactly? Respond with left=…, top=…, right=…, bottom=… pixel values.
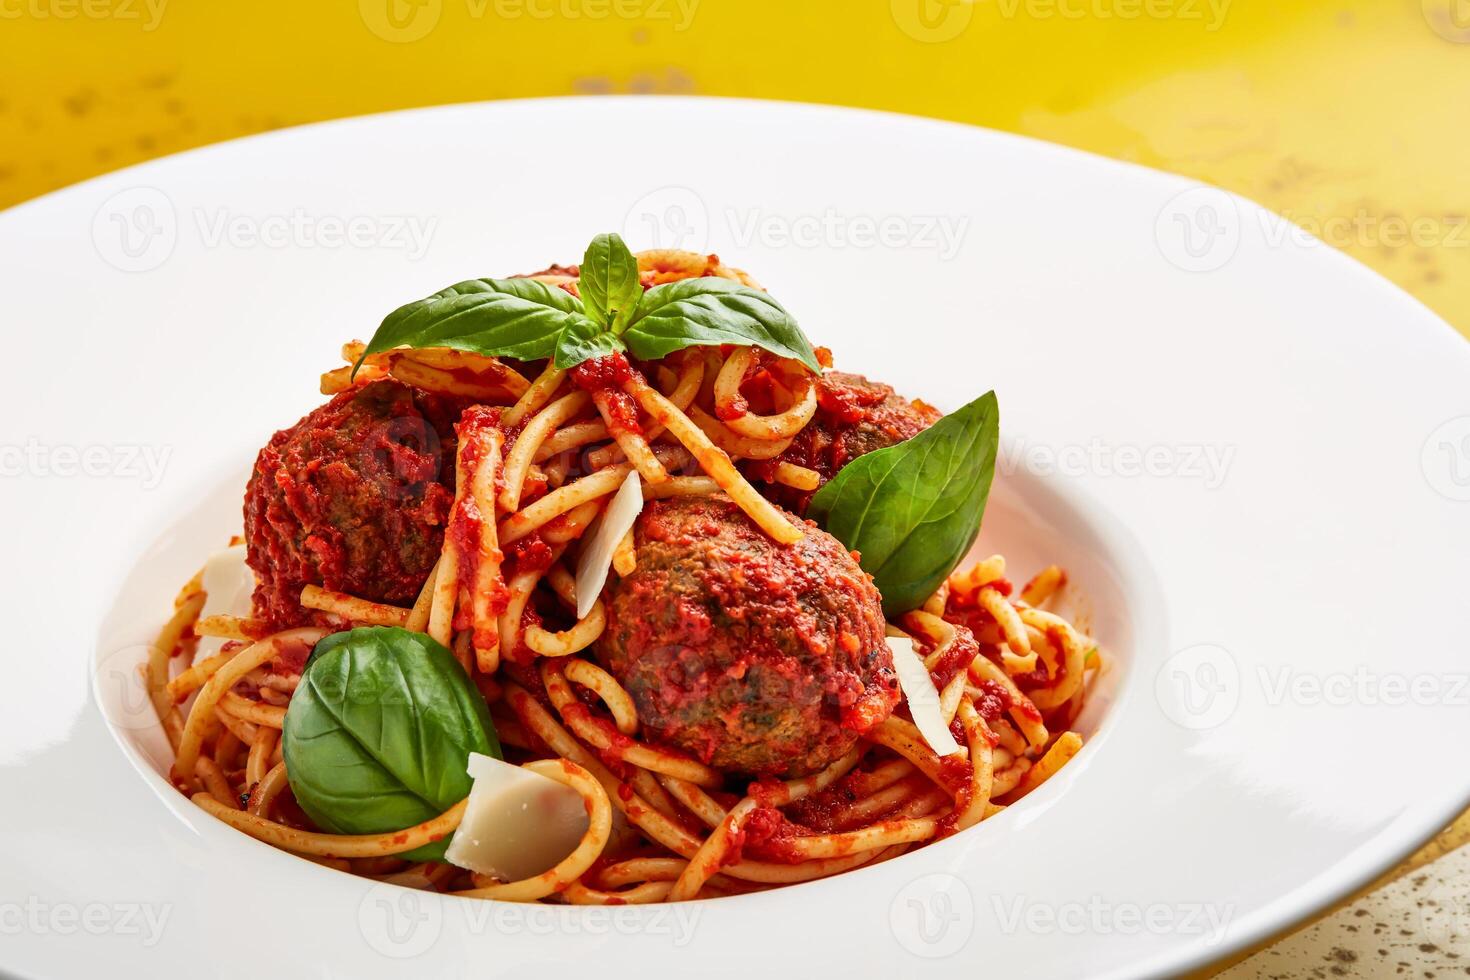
left=245, top=381, right=460, bottom=627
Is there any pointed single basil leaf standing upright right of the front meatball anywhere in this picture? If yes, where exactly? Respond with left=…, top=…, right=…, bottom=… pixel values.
left=807, top=391, right=1000, bottom=616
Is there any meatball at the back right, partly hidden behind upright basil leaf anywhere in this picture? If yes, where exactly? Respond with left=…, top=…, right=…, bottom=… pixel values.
left=747, top=370, right=941, bottom=513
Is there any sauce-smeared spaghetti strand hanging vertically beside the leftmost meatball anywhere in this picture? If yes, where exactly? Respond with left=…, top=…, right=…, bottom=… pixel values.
left=445, top=423, right=506, bottom=674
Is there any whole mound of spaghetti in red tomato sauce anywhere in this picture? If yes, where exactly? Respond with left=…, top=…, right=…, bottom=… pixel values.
left=146, top=251, right=1104, bottom=904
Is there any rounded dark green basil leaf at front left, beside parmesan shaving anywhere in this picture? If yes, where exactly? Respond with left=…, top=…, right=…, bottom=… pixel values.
left=281, top=627, right=501, bottom=861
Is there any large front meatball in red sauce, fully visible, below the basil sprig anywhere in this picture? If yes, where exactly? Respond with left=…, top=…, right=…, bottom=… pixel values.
left=595, top=495, right=898, bottom=776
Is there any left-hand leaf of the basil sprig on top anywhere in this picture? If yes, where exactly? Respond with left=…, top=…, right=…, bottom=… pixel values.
left=359, top=279, right=582, bottom=371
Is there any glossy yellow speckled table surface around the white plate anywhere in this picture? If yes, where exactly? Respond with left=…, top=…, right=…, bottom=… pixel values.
left=0, top=0, right=1470, bottom=963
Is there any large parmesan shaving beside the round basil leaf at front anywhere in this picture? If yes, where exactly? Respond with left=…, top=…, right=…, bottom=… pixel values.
left=444, top=752, right=591, bottom=882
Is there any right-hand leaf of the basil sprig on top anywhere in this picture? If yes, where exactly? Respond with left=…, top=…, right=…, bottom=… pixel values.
left=623, top=276, right=822, bottom=373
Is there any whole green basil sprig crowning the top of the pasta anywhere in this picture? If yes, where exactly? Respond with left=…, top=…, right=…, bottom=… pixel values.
left=359, top=234, right=822, bottom=373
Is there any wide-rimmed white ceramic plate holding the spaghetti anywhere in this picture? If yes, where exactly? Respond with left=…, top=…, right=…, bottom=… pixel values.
left=0, top=100, right=1470, bottom=977
